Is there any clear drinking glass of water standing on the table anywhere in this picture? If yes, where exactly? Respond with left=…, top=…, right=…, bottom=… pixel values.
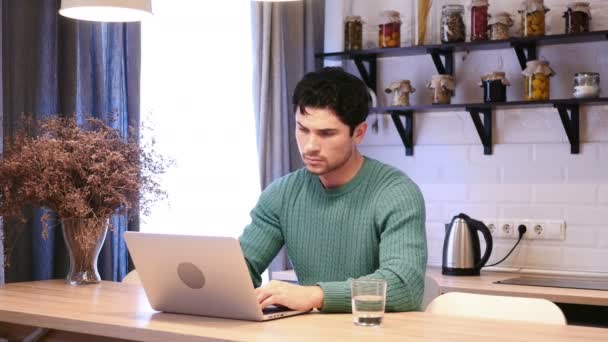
left=350, top=278, right=386, bottom=326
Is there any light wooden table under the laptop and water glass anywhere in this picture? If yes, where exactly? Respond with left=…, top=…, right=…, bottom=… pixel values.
left=0, top=280, right=608, bottom=342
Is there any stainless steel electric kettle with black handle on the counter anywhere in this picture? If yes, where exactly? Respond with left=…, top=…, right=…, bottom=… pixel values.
left=441, top=213, right=492, bottom=275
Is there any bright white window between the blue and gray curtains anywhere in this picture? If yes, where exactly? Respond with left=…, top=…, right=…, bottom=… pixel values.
left=141, top=0, right=260, bottom=237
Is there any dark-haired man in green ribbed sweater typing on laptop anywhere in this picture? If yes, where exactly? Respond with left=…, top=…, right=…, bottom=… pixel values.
left=240, top=68, right=427, bottom=312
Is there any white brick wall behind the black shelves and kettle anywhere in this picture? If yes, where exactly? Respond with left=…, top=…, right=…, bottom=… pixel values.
left=326, top=0, right=608, bottom=272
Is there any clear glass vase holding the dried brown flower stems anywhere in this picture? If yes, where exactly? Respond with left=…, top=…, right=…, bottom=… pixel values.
left=61, top=218, right=109, bottom=285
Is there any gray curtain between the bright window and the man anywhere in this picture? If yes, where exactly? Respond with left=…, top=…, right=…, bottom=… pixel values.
left=252, top=0, right=325, bottom=271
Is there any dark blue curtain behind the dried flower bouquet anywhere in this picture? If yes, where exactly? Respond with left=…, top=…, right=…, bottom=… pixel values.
left=2, top=0, right=141, bottom=282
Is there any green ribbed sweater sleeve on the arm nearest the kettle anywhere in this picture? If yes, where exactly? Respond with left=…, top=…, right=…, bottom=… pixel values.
left=317, top=181, right=427, bottom=312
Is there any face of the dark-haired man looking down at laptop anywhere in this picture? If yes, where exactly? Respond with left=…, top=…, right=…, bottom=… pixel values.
left=296, top=107, right=367, bottom=176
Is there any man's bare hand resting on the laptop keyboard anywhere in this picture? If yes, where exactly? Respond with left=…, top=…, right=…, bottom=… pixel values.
left=255, top=280, right=323, bottom=311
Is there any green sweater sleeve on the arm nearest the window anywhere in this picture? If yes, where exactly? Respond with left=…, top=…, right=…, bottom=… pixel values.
left=239, top=181, right=284, bottom=287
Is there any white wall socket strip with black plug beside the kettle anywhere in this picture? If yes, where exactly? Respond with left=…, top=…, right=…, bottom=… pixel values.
left=482, top=219, right=566, bottom=240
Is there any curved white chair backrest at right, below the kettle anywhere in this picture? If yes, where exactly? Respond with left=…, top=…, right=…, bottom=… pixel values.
left=426, top=292, right=566, bottom=325
